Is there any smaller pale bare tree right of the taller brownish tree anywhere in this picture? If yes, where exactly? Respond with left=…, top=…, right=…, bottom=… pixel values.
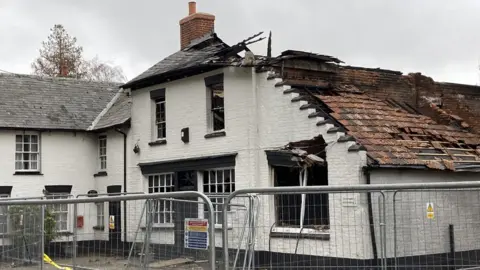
left=83, top=56, right=127, bottom=82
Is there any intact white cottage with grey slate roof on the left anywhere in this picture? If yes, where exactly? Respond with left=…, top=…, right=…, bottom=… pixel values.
left=0, top=74, right=130, bottom=255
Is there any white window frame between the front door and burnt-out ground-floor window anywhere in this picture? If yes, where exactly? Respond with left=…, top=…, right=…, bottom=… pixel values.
left=199, top=167, right=235, bottom=227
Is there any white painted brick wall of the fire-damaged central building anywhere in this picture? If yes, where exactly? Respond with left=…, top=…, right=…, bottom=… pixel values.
left=128, top=68, right=371, bottom=258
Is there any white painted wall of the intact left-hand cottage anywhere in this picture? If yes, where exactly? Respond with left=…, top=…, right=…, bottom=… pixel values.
left=0, top=130, right=123, bottom=241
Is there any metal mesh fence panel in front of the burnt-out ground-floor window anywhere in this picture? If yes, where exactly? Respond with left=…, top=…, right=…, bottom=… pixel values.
left=224, top=188, right=384, bottom=269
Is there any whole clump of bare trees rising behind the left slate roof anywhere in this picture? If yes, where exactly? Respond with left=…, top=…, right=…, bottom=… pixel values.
left=32, top=24, right=126, bottom=82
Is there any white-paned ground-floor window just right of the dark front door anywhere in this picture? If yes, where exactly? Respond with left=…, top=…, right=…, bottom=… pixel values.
left=203, top=168, right=235, bottom=224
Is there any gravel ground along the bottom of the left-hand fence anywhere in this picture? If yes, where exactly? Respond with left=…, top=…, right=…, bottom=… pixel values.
left=0, top=257, right=207, bottom=270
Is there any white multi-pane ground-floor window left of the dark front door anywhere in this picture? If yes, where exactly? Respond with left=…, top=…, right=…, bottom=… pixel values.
left=147, top=172, right=175, bottom=225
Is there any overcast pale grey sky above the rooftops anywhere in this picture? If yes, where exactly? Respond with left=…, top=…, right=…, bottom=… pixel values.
left=0, top=0, right=480, bottom=84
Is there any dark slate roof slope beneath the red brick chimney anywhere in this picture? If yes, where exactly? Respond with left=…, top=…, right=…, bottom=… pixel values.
left=122, top=34, right=228, bottom=88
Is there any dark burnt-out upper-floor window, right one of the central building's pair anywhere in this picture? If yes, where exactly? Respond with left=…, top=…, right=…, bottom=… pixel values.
left=205, top=74, right=225, bottom=131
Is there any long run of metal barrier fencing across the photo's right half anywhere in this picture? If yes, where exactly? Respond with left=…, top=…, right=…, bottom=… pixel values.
left=222, top=182, right=480, bottom=269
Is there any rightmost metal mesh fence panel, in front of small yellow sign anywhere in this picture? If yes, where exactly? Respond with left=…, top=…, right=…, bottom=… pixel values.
left=387, top=188, right=480, bottom=269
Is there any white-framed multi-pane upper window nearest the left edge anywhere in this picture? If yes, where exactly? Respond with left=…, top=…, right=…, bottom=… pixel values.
left=15, top=133, right=40, bottom=172
